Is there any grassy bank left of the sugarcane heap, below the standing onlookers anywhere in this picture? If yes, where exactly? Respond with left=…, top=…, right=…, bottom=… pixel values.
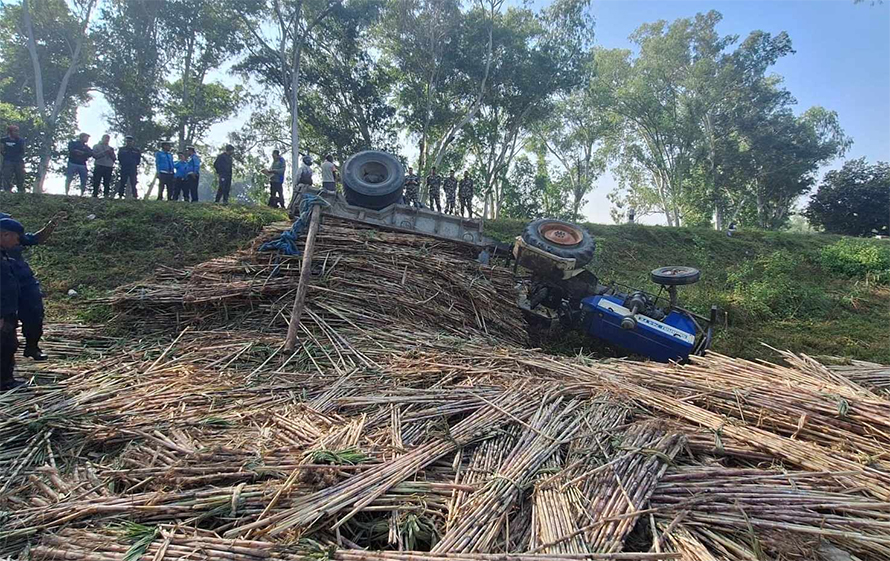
left=0, top=193, right=287, bottom=321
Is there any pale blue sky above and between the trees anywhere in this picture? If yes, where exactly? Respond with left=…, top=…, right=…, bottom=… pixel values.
left=55, top=0, right=890, bottom=224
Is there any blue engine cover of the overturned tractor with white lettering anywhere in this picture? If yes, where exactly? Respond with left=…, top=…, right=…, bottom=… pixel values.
left=581, top=295, right=696, bottom=362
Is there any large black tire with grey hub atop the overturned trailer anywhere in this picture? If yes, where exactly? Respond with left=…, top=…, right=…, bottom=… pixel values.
left=343, top=150, right=405, bottom=210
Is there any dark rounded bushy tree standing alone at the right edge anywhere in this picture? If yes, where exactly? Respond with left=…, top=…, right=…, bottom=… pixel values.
left=804, top=158, right=890, bottom=236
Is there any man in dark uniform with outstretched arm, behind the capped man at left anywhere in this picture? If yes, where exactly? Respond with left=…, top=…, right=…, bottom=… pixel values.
left=0, top=212, right=67, bottom=361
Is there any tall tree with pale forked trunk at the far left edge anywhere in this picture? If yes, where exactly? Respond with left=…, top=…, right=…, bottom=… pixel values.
left=0, top=0, right=96, bottom=192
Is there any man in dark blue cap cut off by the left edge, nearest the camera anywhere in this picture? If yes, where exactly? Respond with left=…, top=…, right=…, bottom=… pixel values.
left=0, top=218, right=25, bottom=391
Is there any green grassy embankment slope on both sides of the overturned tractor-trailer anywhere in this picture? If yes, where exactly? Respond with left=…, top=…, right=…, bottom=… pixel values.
left=0, top=193, right=890, bottom=363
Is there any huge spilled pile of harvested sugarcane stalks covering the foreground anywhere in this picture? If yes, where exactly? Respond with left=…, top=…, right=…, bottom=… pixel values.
left=0, top=217, right=890, bottom=561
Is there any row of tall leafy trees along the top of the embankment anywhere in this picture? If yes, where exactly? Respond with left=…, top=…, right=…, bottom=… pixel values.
left=0, top=0, right=851, bottom=229
